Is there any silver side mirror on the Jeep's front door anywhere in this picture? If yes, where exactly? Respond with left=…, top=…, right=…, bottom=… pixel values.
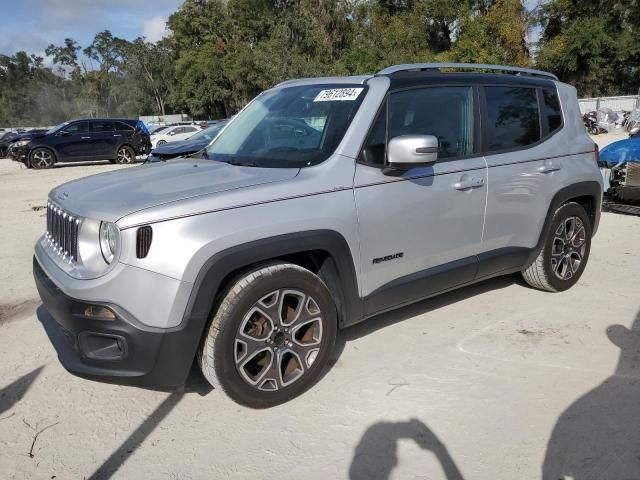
left=387, top=135, right=439, bottom=171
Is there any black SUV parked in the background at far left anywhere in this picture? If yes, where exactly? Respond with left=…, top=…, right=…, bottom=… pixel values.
left=9, top=118, right=151, bottom=169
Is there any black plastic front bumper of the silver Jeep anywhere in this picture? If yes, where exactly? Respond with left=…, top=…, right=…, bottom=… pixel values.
left=33, top=257, right=203, bottom=388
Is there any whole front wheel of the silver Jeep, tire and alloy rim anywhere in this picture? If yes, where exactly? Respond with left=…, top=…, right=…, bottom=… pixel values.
left=198, top=262, right=337, bottom=408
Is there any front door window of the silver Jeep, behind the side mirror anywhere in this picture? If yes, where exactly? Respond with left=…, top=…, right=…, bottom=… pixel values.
left=388, top=86, right=473, bottom=158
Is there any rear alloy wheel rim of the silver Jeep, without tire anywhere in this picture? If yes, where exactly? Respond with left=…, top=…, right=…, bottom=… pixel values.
left=551, top=216, right=587, bottom=281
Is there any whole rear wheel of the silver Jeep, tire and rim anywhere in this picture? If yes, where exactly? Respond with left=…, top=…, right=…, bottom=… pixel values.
left=522, top=202, right=592, bottom=292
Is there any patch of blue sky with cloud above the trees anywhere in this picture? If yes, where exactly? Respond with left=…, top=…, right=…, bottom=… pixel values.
left=0, top=0, right=183, bottom=57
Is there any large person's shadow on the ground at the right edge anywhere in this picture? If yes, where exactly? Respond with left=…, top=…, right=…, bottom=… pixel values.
left=542, top=312, right=640, bottom=480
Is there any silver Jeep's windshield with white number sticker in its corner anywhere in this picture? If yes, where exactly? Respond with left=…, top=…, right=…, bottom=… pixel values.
left=206, top=85, right=365, bottom=168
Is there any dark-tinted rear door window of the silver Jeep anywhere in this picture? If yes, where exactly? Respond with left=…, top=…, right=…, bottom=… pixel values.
left=484, top=87, right=540, bottom=152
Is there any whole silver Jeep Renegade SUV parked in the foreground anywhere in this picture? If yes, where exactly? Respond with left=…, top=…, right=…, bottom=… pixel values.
left=33, top=64, right=602, bottom=407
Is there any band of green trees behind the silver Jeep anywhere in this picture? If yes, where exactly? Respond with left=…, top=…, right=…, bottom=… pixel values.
left=0, top=0, right=640, bottom=125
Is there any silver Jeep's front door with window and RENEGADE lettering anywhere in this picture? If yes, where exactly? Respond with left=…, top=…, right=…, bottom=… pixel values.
left=354, top=86, right=487, bottom=314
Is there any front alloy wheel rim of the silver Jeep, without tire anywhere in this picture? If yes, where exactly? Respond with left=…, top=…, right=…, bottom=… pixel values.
left=234, top=288, right=322, bottom=391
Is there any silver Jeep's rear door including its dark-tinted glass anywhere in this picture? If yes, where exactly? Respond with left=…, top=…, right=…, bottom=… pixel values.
left=478, top=85, right=570, bottom=276
